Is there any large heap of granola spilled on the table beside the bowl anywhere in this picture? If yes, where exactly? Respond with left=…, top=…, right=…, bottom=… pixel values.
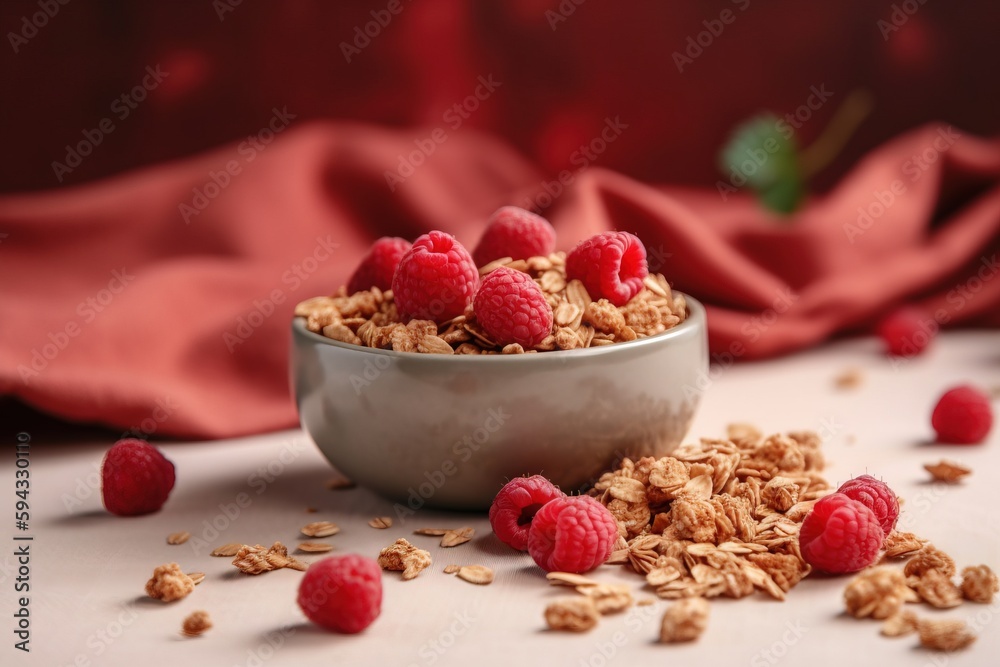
left=591, top=425, right=829, bottom=600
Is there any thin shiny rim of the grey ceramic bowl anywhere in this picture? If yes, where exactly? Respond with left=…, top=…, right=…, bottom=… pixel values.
left=292, top=290, right=707, bottom=364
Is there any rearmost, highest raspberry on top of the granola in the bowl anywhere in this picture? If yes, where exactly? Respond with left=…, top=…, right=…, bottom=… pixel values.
left=472, top=206, right=556, bottom=266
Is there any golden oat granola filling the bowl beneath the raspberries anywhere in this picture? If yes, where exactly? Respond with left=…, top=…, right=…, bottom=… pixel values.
left=295, top=252, right=687, bottom=354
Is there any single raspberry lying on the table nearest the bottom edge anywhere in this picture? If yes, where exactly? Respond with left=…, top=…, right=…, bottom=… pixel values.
left=298, top=554, right=382, bottom=634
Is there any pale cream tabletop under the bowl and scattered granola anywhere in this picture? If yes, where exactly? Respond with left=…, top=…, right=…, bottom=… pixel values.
left=0, top=331, right=1000, bottom=667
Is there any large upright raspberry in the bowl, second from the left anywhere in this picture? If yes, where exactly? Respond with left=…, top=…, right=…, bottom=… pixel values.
left=392, top=231, right=479, bottom=324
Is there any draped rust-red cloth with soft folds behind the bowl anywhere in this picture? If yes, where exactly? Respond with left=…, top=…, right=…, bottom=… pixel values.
left=0, top=123, right=1000, bottom=437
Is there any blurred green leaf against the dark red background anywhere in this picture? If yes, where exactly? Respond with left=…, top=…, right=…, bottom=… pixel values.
left=719, top=114, right=805, bottom=214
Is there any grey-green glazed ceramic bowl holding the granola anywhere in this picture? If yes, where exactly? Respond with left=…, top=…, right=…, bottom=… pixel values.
left=291, top=297, right=708, bottom=513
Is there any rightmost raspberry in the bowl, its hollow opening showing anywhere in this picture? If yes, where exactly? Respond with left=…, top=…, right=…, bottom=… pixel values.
left=566, top=232, right=649, bottom=306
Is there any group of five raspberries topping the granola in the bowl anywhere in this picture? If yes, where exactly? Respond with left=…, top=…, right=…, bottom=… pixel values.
left=347, top=206, right=648, bottom=348
